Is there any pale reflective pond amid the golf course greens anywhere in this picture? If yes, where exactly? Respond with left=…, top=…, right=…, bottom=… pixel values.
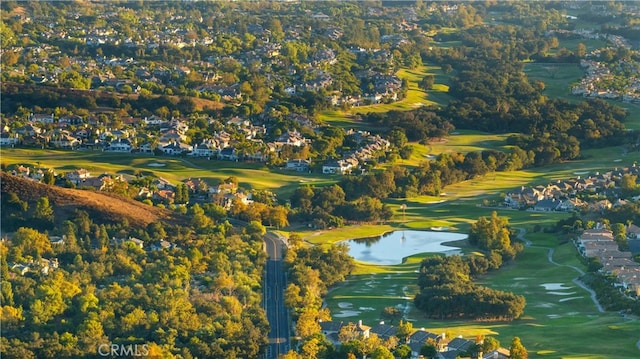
left=346, top=231, right=467, bottom=265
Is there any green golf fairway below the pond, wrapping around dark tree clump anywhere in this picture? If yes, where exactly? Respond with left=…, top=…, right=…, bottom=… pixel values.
left=326, top=233, right=640, bottom=358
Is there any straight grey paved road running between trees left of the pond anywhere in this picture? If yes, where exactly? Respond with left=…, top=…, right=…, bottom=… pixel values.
left=264, top=233, right=290, bottom=359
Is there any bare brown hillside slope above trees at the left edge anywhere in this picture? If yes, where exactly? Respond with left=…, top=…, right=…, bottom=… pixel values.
left=0, top=173, right=185, bottom=227
